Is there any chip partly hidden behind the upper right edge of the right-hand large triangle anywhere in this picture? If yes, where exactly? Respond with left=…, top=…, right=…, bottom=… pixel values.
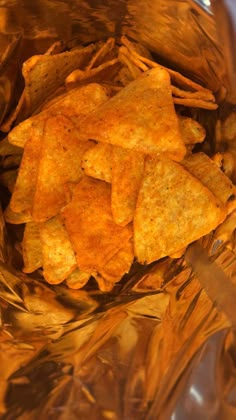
left=181, top=153, right=236, bottom=210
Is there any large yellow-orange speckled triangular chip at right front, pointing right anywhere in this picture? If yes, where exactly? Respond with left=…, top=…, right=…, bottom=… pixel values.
left=134, top=158, right=227, bottom=263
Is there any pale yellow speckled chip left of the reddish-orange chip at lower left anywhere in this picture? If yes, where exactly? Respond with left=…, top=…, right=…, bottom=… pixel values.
left=39, top=216, right=77, bottom=284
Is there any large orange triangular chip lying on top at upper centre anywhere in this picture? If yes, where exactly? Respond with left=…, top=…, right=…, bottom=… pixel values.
left=79, top=68, right=186, bottom=160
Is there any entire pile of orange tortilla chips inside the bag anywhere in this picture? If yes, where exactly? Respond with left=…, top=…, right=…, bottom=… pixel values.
left=0, top=37, right=236, bottom=291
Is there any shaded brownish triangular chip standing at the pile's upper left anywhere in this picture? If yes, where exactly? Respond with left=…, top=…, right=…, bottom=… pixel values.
left=22, top=44, right=95, bottom=113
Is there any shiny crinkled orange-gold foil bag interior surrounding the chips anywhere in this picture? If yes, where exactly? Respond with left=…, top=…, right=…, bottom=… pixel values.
left=0, top=0, right=236, bottom=420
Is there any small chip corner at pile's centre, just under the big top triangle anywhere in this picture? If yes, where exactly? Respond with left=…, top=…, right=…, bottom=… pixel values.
left=82, top=143, right=112, bottom=182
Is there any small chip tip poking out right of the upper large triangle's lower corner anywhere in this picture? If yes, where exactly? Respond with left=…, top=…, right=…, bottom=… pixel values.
left=178, top=115, right=206, bottom=144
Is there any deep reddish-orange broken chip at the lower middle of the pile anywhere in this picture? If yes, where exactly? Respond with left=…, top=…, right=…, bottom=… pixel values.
left=62, top=177, right=132, bottom=272
